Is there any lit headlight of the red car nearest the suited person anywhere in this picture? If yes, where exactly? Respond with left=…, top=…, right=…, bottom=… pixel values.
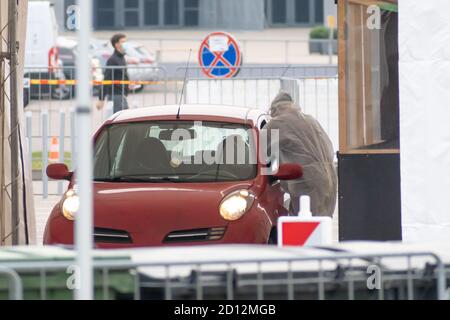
left=219, top=189, right=255, bottom=221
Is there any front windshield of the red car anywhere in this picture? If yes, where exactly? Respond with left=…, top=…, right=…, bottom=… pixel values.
left=94, top=121, right=257, bottom=182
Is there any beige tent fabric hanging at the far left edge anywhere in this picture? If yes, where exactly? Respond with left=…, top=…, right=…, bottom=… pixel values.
left=0, top=0, right=36, bottom=246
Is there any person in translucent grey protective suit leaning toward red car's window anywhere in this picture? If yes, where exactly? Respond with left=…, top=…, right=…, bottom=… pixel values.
left=264, top=91, right=337, bottom=217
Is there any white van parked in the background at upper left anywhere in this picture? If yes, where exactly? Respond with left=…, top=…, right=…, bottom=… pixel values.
left=24, top=1, right=70, bottom=99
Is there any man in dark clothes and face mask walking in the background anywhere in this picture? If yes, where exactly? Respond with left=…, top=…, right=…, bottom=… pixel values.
left=97, top=33, right=129, bottom=113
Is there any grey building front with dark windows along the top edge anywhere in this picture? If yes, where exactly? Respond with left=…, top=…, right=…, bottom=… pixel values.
left=48, top=0, right=336, bottom=30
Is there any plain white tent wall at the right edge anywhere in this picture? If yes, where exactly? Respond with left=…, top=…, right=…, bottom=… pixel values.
left=399, top=0, right=450, bottom=242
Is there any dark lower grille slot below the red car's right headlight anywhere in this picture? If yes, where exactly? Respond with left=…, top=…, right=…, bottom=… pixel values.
left=163, top=227, right=226, bottom=243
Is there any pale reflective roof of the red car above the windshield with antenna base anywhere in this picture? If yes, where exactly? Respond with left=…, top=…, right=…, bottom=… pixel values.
left=112, top=104, right=267, bottom=123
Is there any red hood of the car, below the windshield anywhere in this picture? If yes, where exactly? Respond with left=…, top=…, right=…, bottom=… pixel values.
left=94, top=182, right=252, bottom=241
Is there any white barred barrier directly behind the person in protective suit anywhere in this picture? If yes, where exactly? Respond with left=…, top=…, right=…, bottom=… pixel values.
left=184, top=76, right=339, bottom=157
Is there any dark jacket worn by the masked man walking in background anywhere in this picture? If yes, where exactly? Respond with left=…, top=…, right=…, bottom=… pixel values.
left=100, top=50, right=129, bottom=100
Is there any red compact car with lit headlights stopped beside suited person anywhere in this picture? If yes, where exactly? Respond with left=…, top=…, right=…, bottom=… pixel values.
left=44, top=105, right=302, bottom=248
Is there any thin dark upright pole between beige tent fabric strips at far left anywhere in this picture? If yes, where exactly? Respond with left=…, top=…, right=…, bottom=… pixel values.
left=8, top=0, right=20, bottom=245
